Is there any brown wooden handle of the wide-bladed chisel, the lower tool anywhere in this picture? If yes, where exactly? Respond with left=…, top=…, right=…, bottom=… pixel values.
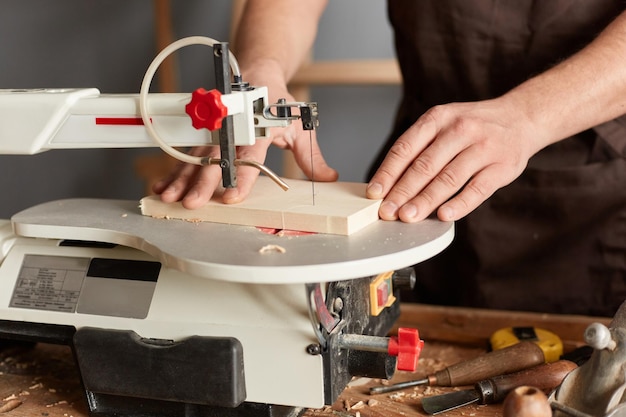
left=476, top=360, right=576, bottom=404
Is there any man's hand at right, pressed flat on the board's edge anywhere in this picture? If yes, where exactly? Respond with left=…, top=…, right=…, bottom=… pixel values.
left=367, top=99, right=542, bottom=222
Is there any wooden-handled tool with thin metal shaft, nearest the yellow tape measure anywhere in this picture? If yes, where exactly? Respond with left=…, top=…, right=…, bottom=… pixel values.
left=370, top=341, right=545, bottom=394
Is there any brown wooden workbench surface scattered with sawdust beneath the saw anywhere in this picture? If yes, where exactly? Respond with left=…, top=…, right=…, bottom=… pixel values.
left=0, top=304, right=610, bottom=417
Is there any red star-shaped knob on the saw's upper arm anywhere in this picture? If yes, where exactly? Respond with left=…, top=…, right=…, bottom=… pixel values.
left=185, top=88, right=228, bottom=130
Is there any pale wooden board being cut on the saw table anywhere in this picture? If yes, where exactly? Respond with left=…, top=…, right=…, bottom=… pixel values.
left=141, top=176, right=380, bottom=235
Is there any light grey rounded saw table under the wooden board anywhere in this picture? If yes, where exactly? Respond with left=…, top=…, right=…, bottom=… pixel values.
left=11, top=199, right=454, bottom=284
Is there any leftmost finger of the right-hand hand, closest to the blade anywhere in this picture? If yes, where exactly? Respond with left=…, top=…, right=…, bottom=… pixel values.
left=366, top=111, right=438, bottom=199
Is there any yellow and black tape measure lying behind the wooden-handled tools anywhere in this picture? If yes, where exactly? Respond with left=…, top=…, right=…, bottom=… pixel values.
left=489, top=327, right=563, bottom=362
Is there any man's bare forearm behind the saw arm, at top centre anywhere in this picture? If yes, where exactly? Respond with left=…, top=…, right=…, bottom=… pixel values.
left=234, top=0, right=327, bottom=83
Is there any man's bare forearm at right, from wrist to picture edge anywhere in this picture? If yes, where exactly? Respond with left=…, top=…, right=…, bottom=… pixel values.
left=501, top=13, right=626, bottom=152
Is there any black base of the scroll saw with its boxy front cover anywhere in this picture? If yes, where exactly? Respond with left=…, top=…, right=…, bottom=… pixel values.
left=0, top=320, right=304, bottom=417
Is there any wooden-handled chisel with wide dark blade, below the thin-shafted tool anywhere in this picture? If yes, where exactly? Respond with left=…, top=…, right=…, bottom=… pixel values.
left=422, top=360, right=576, bottom=415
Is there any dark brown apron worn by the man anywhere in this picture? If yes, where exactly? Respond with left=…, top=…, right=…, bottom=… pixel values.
left=375, top=0, right=626, bottom=316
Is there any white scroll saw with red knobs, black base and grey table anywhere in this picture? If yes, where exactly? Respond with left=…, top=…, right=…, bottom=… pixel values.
left=0, top=37, right=454, bottom=417
